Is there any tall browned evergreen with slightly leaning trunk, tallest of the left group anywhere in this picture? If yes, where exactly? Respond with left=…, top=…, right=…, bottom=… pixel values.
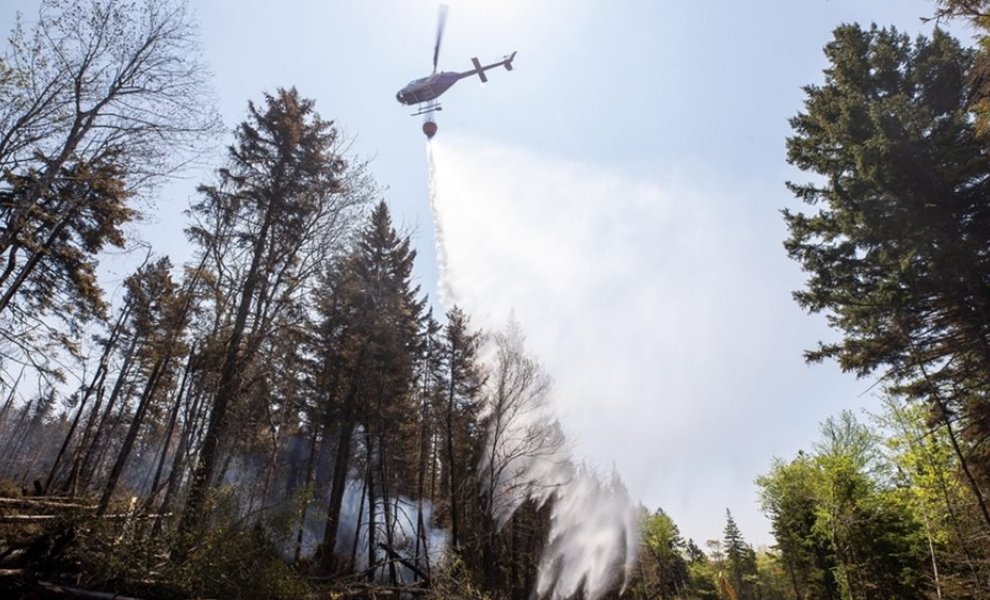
left=183, top=89, right=346, bottom=530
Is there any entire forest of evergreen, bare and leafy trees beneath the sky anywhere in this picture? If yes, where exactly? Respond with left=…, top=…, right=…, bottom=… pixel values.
left=0, top=0, right=990, bottom=600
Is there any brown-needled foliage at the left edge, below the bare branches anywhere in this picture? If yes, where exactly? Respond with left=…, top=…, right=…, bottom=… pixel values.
left=0, top=155, right=134, bottom=367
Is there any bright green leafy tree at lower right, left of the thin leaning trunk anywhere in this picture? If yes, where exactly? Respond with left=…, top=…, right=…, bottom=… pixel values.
left=757, top=413, right=932, bottom=599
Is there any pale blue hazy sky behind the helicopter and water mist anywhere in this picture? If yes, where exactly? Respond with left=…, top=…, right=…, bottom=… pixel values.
left=0, top=0, right=965, bottom=543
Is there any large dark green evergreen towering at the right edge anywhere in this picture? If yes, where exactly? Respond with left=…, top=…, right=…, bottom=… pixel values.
left=784, top=25, right=990, bottom=531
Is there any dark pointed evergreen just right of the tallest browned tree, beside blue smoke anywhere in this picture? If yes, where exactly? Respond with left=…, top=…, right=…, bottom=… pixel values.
left=323, top=202, right=423, bottom=575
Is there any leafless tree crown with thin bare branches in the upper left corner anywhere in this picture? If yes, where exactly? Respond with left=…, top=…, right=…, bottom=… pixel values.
left=0, top=0, right=219, bottom=192
